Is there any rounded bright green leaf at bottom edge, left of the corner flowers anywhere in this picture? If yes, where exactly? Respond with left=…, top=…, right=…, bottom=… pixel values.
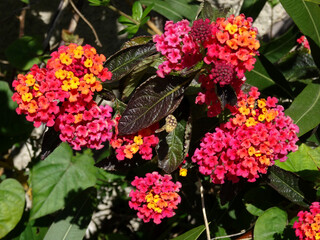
left=253, top=207, right=288, bottom=240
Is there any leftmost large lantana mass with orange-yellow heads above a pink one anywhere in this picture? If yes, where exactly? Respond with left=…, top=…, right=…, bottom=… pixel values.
left=12, top=44, right=114, bottom=150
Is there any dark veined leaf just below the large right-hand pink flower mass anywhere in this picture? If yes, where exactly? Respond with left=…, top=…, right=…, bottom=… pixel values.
left=267, top=166, right=314, bottom=207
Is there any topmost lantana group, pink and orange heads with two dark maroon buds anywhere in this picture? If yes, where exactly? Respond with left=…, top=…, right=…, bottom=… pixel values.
left=153, top=14, right=260, bottom=117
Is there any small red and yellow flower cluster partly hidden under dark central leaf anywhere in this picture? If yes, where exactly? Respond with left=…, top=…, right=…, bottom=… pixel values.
left=110, top=116, right=159, bottom=160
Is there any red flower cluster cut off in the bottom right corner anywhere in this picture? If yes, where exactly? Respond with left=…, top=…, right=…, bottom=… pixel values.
left=293, top=202, right=320, bottom=240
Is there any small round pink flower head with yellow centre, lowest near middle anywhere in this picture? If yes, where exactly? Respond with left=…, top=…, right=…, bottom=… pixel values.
left=129, top=172, right=181, bottom=224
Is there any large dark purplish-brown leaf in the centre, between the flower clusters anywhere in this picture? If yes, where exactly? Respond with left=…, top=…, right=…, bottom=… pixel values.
left=118, top=76, right=192, bottom=135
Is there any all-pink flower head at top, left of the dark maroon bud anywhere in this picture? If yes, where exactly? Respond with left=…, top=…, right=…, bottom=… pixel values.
left=153, top=20, right=202, bottom=78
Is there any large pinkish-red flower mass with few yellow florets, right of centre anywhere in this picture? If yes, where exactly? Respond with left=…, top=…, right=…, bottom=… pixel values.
left=192, top=87, right=299, bottom=184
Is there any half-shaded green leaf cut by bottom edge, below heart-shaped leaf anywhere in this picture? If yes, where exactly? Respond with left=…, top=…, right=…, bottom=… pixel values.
left=44, top=188, right=97, bottom=240
